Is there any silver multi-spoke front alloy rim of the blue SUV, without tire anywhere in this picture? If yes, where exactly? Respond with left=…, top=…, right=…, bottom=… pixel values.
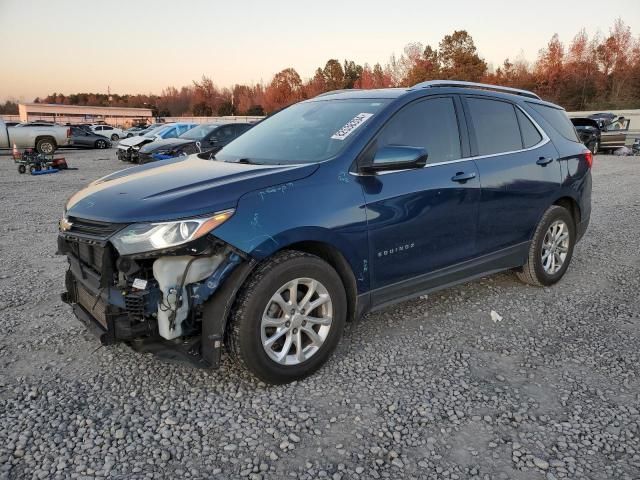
left=260, top=278, right=333, bottom=365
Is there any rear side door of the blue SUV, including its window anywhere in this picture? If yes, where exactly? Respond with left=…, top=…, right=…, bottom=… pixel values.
left=463, top=96, right=562, bottom=256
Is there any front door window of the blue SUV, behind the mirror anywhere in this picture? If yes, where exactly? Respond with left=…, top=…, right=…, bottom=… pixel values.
left=378, top=97, right=462, bottom=163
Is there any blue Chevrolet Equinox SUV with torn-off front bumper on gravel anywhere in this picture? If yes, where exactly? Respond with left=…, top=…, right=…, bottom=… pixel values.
left=58, top=81, right=592, bottom=383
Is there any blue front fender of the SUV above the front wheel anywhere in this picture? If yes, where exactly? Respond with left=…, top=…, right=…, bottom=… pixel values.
left=214, top=168, right=369, bottom=292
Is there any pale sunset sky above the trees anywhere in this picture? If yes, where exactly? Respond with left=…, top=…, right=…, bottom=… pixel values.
left=0, top=0, right=640, bottom=101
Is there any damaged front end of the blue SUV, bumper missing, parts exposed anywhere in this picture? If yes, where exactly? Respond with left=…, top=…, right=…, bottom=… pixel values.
left=58, top=212, right=253, bottom=368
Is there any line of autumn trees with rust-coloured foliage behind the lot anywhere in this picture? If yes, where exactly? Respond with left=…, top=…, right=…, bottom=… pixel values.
left=0, top=19, right=640, bottom=116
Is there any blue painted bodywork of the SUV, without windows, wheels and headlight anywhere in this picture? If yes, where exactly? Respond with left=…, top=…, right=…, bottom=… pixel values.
left=67, top=88, right=591, bottom=304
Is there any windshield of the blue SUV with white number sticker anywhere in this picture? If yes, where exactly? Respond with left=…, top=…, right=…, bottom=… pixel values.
left=215, top=99, right=390, bottom=164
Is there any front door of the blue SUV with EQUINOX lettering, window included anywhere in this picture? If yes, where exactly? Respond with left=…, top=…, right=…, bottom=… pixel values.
left=358, top=96, right=480, bottom=304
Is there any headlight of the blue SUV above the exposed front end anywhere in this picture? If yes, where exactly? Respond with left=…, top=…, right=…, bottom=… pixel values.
left=111, top=210, right=234, bottom=255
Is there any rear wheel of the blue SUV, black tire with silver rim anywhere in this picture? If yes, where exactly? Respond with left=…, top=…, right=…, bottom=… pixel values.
left=516, top=205, right=576, bottom=287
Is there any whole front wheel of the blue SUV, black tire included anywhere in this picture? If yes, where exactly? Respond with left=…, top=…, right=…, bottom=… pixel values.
left=227, top=250, right=347, bottom=384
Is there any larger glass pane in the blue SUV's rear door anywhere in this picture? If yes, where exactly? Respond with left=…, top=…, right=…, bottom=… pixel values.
left=467, top=97, right=522, bottom=155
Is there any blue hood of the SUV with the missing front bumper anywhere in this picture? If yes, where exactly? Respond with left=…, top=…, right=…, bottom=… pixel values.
left=66, top=155, right=318, bottom=223
